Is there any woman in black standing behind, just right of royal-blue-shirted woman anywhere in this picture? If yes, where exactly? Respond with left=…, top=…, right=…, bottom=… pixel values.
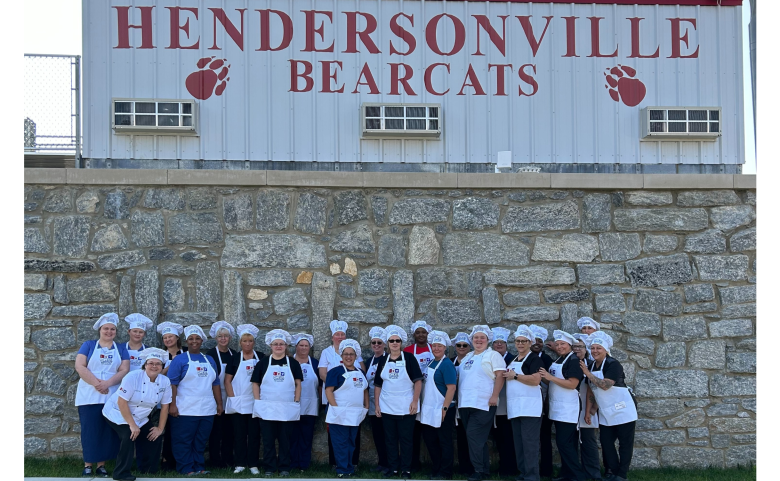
left=206, top=321, right=238, bottom=468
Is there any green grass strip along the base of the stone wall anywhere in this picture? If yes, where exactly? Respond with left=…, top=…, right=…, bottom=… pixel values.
left=24, top=457, right=756, bottom=481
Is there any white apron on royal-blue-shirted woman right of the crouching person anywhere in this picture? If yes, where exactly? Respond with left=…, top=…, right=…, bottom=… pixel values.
left=176, top=352, right=217, bottom=416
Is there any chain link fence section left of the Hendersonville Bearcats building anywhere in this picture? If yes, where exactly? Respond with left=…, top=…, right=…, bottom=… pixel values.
left=24, top=54, right=81, bottom=158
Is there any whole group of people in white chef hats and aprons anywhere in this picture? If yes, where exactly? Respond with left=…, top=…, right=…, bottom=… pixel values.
left=76, top=313, right=637, bottom=481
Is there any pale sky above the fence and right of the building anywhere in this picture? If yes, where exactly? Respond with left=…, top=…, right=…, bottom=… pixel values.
left=24, top=0, right=756, bottom=174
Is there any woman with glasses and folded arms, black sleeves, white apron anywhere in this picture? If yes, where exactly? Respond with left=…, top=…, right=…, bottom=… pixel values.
left=504, top=324, right=544, bottom=481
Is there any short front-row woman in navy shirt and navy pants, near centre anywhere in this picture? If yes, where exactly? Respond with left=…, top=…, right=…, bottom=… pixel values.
left=325, top=339, right=368, bottom=478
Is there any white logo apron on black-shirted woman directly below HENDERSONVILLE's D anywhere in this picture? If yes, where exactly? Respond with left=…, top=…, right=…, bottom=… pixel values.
left=252, top=356, right=301, bottom=421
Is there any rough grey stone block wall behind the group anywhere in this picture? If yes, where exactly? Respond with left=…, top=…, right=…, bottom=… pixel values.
left=24, top=173, right=756, bottom=467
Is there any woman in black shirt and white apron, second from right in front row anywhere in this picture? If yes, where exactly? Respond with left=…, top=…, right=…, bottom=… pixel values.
left=539, top=329, right=587, bottom=481
